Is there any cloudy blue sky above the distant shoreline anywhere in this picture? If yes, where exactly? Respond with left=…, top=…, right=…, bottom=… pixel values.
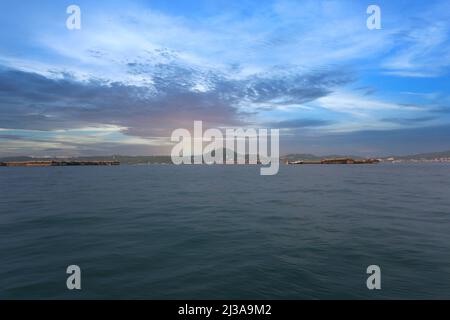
left=0, top=0, right=450, bottom=157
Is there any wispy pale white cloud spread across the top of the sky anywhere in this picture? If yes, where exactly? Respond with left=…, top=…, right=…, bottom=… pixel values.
left=3, top=0, right=394, bottom=85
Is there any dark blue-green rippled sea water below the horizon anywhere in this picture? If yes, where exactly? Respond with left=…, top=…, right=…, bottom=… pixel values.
left=0, top=164, right=450, bottom=299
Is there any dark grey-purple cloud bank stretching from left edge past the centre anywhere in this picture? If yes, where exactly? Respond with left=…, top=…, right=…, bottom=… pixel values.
left=0, top=64, right=348, bottom=137
